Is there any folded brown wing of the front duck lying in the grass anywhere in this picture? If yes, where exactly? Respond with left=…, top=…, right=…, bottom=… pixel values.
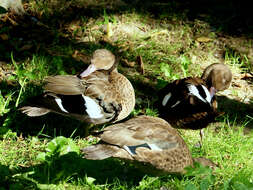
left=83, top=116, right=184, bottom=156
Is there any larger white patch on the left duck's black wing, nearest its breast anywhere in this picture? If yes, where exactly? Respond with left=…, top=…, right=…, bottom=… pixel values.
left=82, top=95, right=103, bottom=119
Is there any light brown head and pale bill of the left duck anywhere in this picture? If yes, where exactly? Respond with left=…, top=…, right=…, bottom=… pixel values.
left=79, top=49, right=115, bottom=78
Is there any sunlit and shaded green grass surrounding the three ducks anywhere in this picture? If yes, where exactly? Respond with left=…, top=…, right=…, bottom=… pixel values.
left=0, top=0, right=253, bottom=190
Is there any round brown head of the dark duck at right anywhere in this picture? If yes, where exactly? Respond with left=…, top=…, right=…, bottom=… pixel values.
left=201, top=63, right=232, bottom=91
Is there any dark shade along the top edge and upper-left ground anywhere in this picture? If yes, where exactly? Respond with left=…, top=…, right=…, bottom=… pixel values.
left=0, top=0, right=253, bottom=61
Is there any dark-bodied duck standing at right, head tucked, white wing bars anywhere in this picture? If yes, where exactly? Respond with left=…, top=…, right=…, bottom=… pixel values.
left=159, top=63, right=232, bottom=140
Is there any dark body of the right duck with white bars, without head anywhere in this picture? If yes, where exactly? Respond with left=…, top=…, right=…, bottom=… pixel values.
left=158, top=77, right=220, bottom=130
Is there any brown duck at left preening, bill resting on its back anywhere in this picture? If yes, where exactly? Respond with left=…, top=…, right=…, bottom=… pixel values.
left=20, top=49, right=135, bottom=125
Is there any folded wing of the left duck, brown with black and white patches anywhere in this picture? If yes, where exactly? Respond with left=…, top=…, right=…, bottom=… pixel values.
left=21, top=72, right=121, bottom=124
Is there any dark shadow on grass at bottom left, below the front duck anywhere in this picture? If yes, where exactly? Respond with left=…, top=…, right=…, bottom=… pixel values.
left=0, top=152, right=150, bottom=189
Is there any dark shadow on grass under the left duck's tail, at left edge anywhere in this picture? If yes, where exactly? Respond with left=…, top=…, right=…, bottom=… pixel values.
left=0, top=82, right=91, bottom=137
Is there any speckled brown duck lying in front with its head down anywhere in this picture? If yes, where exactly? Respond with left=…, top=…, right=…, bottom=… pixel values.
left=81, top=115, right=215, bottom=175
